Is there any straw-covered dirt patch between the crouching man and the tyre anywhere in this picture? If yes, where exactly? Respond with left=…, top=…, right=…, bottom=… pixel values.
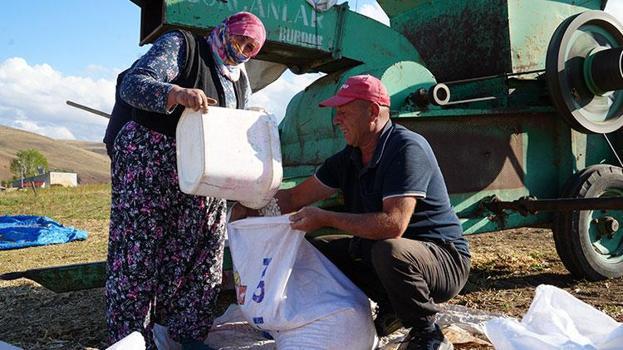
left=452, top=228, right=623, bottom=322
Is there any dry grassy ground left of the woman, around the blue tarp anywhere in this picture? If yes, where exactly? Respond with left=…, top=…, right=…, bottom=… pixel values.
left=0, top=185, right=110, bottom=349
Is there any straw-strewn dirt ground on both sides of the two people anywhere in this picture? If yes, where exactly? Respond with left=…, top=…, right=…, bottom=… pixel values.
left=0, top=228, right=623, bottom=349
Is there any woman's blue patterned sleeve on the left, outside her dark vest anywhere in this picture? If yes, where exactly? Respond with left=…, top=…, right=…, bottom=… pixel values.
left=119, top=31, right=186, bottom=113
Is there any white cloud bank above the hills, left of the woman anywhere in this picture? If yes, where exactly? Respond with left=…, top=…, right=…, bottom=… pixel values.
left=0, top=57, right=115, bottom=141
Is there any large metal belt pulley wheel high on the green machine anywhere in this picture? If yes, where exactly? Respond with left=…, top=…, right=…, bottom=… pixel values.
left=545, top=11, right=623, bottom=134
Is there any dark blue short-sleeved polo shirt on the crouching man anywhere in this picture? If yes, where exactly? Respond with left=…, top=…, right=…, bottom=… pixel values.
left=316, top=121, right=469, bottom=256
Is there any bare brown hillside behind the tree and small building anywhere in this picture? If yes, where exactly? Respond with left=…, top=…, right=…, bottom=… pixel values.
left=0, top=125, right=110, bottom=184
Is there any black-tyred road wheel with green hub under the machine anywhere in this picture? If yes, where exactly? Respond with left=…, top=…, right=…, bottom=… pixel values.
left=552, top=164, right=623, bottom=281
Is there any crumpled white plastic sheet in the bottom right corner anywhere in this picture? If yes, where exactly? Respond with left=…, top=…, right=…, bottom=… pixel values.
left=485, top=285, right=623, bottom=350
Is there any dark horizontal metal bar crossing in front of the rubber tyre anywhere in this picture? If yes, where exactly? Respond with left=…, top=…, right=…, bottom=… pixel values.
left=484, top=197, right=623, bottom=215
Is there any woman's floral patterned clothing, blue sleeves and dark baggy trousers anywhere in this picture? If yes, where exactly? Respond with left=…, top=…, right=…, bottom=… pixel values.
left=106, top=31, right=250, bottom=349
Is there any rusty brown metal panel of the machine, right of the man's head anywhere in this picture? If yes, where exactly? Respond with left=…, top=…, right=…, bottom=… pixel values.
left=396, top=114, right=536, bottom=194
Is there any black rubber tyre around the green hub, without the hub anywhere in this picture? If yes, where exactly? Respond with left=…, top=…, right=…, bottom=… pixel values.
left=552, top=164, right=623, bottom=281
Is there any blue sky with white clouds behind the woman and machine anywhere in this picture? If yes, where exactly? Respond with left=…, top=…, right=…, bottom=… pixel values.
left=0, top=0, right=623, bottom=141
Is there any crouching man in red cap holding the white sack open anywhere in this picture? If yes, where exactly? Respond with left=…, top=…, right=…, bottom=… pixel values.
left=235, top=75, right=470, bottom=349
